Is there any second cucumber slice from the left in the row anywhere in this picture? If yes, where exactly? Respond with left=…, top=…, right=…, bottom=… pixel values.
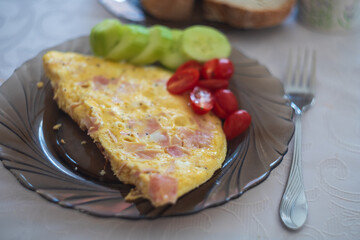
left=106, top=24, right=149, bottom=61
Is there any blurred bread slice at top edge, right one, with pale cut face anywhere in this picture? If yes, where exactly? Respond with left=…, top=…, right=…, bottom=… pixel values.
left=203, top=0, right=295, bottom=28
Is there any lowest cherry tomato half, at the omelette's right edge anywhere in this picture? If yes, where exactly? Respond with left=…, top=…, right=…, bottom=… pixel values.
left=224, top=110, right=251, bottom=140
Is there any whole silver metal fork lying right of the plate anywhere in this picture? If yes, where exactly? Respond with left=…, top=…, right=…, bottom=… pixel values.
left=280, top=50, right=316, bottom=230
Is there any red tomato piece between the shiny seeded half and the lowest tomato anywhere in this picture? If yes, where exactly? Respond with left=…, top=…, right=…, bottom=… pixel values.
left=213, top=89, right=238, bottom=119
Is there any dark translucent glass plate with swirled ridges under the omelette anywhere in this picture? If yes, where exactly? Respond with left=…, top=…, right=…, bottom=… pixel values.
left=0, top=37, right=294, bottom=219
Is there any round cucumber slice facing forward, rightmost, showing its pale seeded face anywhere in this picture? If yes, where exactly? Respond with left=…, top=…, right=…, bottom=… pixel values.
left=182, top=25, right=231, bottom=62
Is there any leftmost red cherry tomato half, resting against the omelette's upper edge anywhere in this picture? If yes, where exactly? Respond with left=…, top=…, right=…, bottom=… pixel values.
left=166, top=68, right=200, bottom=94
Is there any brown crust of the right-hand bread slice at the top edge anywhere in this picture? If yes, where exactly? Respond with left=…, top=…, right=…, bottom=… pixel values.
left=203, top=0, right=296, bottom=29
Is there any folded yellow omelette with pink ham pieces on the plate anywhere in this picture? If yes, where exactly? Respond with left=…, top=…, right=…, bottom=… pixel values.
left=43, top=51, right=226, bottom=207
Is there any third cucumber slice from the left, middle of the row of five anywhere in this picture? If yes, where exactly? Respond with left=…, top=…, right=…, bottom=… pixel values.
left=130, top=25, right=172, bottom=65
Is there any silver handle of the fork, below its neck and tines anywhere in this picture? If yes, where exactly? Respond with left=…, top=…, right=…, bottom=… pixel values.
left=280, top=111, right=308, bottom=230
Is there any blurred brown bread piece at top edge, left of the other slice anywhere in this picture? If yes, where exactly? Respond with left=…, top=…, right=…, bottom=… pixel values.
left=141, top=0, right=194, bottom=21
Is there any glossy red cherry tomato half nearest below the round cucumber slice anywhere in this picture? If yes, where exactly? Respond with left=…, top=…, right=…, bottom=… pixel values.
left=200, top=58, right=234, bottom=80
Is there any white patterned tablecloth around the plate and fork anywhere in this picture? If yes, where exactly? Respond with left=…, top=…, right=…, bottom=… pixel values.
left=0, top=0, right=360, bottom=240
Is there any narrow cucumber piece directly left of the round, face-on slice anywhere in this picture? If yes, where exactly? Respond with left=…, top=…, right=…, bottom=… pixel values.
left=160, top=29, right=188, bottom=70
